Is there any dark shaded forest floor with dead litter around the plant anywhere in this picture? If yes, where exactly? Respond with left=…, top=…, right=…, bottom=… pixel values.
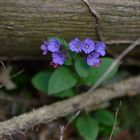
left=0, top=61, right=140, bottom=140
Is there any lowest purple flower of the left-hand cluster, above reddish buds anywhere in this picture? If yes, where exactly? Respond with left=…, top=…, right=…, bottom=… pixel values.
left=52, top=52, right=65, bottom=65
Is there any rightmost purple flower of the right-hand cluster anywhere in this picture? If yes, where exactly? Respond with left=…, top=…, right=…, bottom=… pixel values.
left=95, top=41, right=106, bottom=56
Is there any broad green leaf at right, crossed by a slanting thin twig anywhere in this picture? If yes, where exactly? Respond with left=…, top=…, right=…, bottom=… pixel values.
left=81, top=58, right=118, bottom=85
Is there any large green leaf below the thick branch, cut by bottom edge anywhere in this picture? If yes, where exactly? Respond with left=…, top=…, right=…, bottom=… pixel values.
left=75, top=114, right=99, bottom=140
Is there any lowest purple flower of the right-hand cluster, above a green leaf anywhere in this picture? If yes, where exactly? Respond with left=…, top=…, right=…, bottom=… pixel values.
left=87, top=52, right=100, bottom=67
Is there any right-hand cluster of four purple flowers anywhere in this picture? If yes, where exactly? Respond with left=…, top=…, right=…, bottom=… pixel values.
left=69, top=38, right=106, bottom=66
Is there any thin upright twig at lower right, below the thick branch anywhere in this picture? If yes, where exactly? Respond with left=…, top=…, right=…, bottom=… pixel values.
left=109, top=101, right=122, bottom=140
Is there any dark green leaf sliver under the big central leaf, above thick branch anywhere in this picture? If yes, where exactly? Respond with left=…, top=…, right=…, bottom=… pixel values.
left=53, top=89, right=75, bottom=98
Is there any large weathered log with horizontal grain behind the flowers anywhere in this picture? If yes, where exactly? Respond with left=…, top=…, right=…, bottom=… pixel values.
left=0, top=0, right=140, bottom=57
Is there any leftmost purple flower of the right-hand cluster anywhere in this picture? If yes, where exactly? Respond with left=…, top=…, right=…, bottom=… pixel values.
left=69, top=38, right=82, bottom=53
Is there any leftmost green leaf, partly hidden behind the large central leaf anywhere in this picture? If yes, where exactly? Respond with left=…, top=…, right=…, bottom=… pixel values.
left=31, top=71, right=51, bottom=93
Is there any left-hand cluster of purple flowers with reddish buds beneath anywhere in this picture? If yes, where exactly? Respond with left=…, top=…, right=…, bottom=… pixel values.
left=40, top=38, right=66, bottom=68
